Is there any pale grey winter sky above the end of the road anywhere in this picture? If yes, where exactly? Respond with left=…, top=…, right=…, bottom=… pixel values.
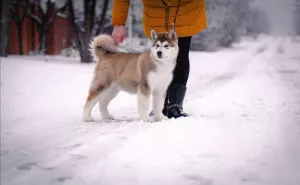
left=256, top=0, right=295, bottom=34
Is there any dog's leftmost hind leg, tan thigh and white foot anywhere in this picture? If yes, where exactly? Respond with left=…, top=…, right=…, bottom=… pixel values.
left=83, top=72, right=110, bottom=122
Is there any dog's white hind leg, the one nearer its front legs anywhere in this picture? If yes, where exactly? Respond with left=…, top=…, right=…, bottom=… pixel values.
left=99, top=85, right=119, bottom=120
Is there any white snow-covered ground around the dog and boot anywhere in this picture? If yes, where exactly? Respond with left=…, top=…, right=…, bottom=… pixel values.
left=1, top=37, right=300, bottom=185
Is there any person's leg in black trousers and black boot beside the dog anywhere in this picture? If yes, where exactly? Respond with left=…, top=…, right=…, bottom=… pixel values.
left=163, top=37, right=191, bottom=118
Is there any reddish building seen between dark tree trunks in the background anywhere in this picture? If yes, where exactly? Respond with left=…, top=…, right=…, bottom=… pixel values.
left=8, top=3, right=72, bottom=55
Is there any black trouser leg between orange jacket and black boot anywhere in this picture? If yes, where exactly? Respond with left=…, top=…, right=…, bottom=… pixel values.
left=171, top=37, right=192, bottom=85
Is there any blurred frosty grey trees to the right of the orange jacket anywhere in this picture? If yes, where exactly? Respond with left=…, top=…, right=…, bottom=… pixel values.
left=191, top=0, right=270, bottom=51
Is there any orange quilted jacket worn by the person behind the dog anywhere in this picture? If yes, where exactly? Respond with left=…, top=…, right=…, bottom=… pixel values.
left=112, top=0, right=207, bottom=37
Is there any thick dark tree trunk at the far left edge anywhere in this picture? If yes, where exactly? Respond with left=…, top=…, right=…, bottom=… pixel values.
left=0, top=0, right=10, bottom=57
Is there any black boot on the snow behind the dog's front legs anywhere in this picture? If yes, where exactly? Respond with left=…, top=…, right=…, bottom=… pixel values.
left=163, top=84, right=189, bottom=119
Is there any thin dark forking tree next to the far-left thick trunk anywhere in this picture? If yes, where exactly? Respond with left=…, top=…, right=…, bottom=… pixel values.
left=9, top=0, right=29, bottom=55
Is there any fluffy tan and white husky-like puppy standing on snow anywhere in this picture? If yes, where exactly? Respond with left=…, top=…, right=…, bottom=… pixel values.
left=83, top=29, right=179, bottom=122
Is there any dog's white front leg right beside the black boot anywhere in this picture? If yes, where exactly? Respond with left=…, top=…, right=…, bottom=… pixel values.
left=153, top=90, right=167, bottom=121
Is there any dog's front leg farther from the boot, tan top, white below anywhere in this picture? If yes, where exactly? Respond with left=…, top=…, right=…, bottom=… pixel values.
left=138, top=85, right=150, bottom=121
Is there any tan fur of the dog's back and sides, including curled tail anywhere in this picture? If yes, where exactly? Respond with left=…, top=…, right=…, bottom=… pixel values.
left=91, top=35, right=155, bottom=93
